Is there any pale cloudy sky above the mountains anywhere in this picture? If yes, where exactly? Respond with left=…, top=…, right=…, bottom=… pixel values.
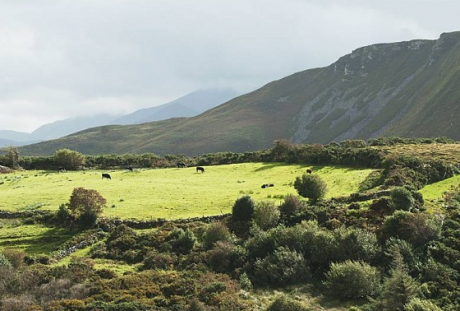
left=0, top=0, right=460, bottom=132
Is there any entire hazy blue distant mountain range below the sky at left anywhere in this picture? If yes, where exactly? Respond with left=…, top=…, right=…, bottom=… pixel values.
left=0, top=88, right=238, bottom=148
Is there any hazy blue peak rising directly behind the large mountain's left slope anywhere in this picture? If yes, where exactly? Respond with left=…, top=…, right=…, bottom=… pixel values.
left=111, top=88, right=238, bottom=125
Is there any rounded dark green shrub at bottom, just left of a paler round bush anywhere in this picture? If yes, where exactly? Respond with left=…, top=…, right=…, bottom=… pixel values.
left=254, top=246, right=310, bottom=286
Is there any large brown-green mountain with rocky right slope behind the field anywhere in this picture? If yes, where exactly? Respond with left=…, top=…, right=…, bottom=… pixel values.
left=22, top=32, right=460, bottom=155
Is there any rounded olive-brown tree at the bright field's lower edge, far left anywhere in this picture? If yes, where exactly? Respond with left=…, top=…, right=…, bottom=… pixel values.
left=67, top=187, right=107, bottom=227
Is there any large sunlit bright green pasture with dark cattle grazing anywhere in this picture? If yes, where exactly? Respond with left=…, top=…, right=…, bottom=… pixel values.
left=0, top=163, right=372, bottom=219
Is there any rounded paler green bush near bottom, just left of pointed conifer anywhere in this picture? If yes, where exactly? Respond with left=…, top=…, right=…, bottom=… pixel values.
left=325, top=260, right=380, bottom=299
